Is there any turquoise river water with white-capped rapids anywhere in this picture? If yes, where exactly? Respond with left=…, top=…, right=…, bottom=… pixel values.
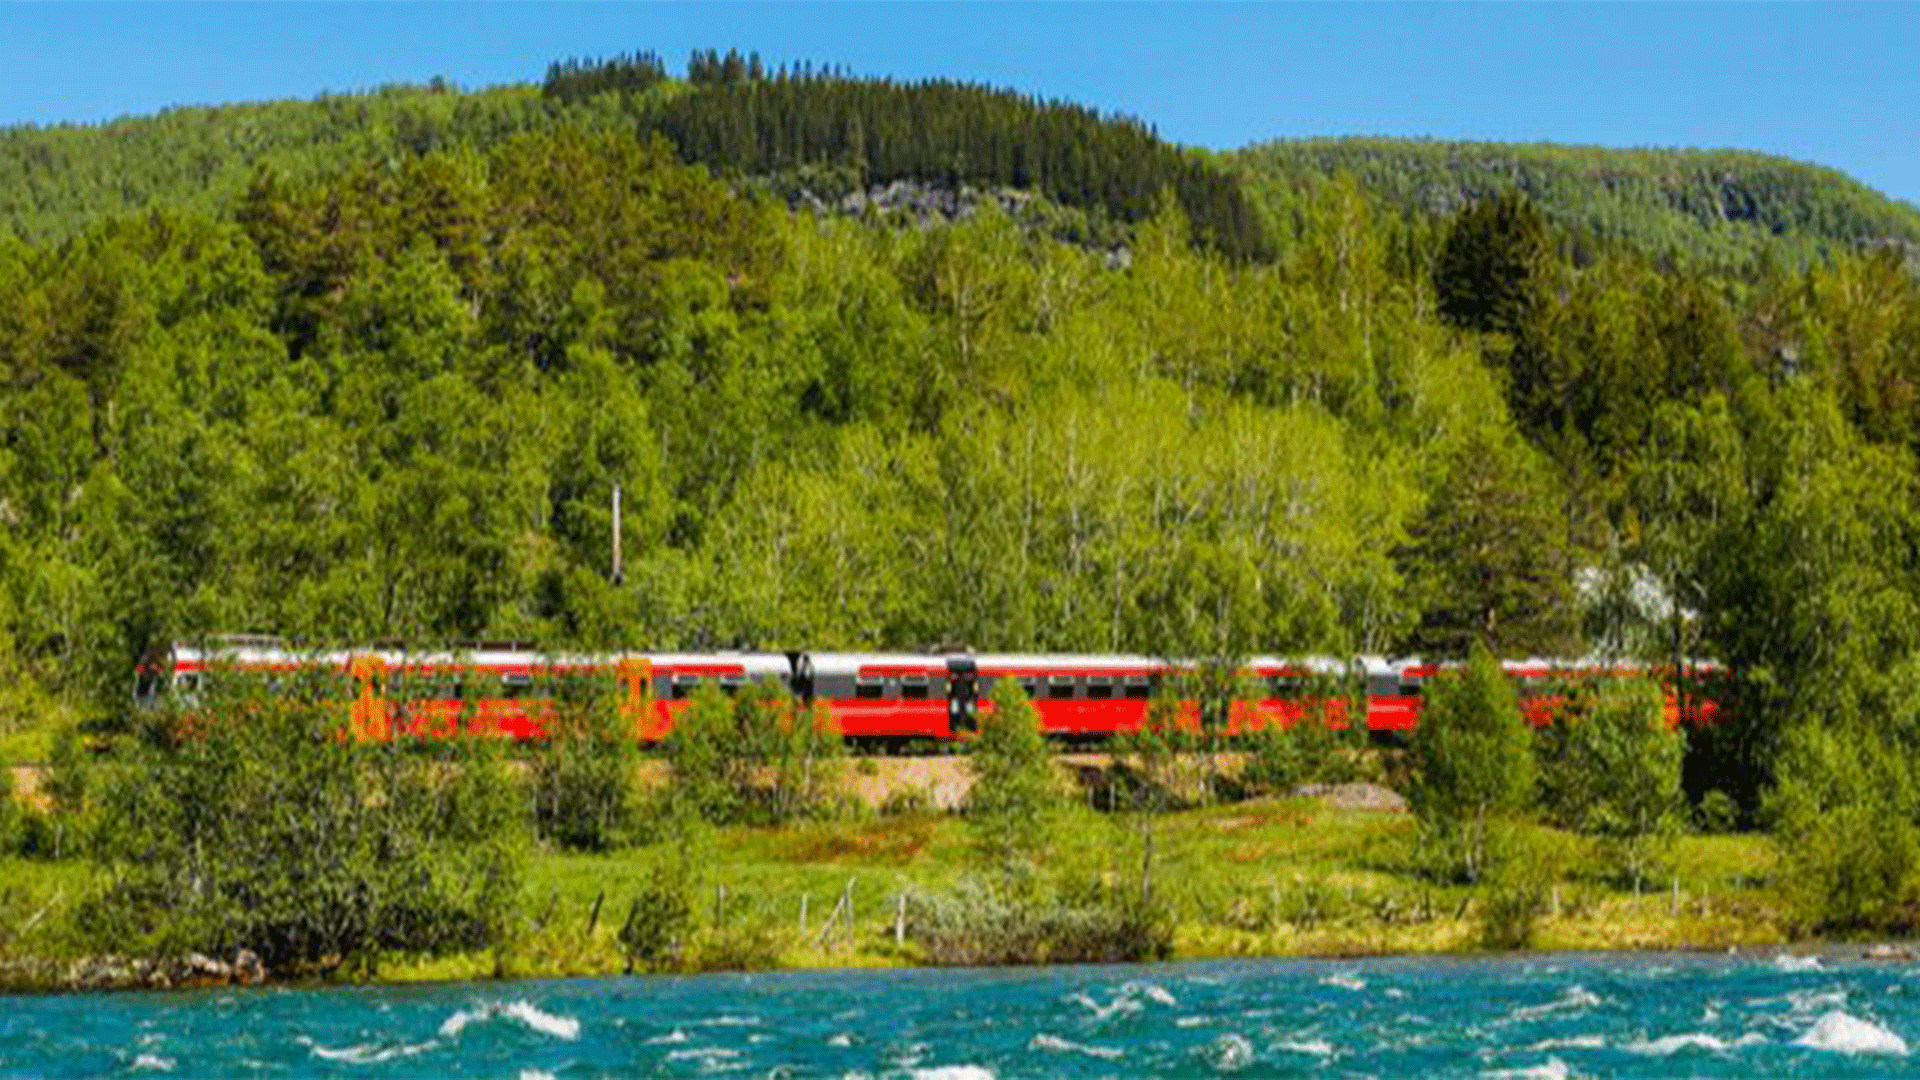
left=0, top=955, right=1920, bottom=1080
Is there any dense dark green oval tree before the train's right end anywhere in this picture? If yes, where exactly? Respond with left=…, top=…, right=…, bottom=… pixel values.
left=1407, top=648, right=1534, bottom=882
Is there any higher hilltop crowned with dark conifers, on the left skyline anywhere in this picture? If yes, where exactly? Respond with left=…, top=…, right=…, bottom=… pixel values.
left=0, top=54, right=1271, bottom=258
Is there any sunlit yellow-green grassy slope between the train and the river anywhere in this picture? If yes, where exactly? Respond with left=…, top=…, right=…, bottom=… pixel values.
left=382, top=799, right=1784, bottom=980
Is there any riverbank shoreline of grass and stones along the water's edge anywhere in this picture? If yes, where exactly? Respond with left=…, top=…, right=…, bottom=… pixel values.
left=0, top=792, right=1797, bottom=994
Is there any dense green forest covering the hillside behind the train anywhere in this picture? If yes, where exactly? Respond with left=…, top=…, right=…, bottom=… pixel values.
left=0, top=58, right=1920, bottom=876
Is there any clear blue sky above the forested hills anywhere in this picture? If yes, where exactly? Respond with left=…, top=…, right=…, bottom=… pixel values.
left=11, top=4, right=1920, bottom=204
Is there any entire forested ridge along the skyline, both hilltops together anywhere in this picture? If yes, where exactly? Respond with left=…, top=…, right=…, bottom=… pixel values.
left=15, top=50, right=1920, bottom=269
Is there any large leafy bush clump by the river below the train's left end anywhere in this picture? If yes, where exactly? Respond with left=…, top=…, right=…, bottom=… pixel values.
left=79, top=664, right=526, bottom=972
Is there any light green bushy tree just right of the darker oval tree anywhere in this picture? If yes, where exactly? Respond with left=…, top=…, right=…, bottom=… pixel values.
left=1540, top=678, right=1686, bottom=890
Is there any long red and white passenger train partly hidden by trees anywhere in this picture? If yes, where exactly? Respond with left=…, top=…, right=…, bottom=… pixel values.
left=138, top=638, right=1715, bottom=742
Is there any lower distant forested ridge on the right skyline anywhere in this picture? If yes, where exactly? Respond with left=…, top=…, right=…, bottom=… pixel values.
left=1231, top=138, right=1920, bottom=271
